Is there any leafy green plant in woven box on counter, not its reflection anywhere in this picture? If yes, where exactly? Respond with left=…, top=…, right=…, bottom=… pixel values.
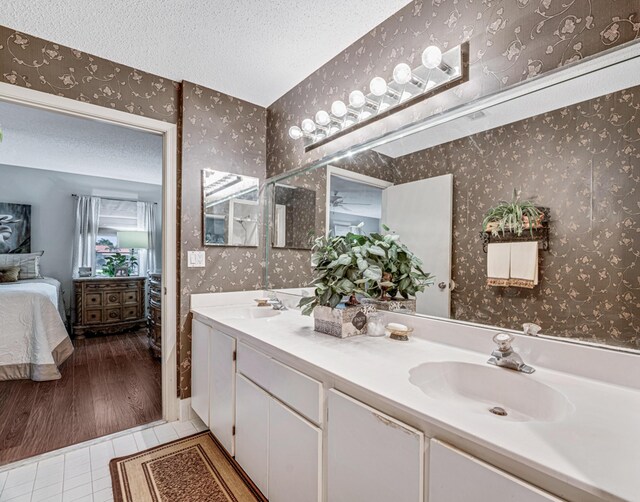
left=298, top=227, right=433, bottom=338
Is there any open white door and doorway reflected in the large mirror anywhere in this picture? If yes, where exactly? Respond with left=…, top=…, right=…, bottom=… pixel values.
left=327, top=167, right=453, bottom=318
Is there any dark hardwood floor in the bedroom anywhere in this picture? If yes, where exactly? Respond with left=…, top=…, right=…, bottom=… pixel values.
left=0, top=329, right=162, bottom=465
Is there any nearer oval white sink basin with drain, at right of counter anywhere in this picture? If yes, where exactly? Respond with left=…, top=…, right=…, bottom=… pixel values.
left=409, top=362, right=573, bottom=422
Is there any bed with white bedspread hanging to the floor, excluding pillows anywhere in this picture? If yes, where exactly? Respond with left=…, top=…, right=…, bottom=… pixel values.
left=0, top=277, right=73, bottom=381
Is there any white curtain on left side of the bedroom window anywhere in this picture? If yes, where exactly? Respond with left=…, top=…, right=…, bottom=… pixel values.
left=72, top=195, right=100, bottom=276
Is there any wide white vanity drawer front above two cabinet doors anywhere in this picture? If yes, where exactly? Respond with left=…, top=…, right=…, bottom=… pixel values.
left=237, top=342, right=322, bottom=424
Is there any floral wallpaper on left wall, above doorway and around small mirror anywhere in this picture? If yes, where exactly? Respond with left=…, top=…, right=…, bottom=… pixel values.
left=0, top=26, right=266, bottom=398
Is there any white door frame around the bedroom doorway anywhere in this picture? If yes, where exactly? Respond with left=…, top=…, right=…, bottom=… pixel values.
left=0, top=82, right=179, bottom=421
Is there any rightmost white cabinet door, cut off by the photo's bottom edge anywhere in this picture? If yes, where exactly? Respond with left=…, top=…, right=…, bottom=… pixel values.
left=428, top=439, right=562, bottom=502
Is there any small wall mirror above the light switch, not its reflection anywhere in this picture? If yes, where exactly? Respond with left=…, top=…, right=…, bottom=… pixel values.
left=202, top=169, right=260, bottom=247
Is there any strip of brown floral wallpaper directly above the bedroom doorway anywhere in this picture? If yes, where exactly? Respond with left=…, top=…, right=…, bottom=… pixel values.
left=0, top=26, right=180, bottom=123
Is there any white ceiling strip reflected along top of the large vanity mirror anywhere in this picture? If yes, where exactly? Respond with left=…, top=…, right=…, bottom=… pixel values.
left=375, top=53, right=640, bottom=158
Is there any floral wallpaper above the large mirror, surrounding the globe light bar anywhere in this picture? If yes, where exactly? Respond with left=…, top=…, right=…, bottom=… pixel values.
left=267, top=0, right=640, bottom=176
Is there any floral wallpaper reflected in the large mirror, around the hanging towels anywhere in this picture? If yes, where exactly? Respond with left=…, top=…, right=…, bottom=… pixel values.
left=269, top=87, right=640, bottom=349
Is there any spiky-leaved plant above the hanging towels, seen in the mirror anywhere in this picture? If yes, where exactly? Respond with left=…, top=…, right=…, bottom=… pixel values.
left=482, top=188, right=544, bottom=237
